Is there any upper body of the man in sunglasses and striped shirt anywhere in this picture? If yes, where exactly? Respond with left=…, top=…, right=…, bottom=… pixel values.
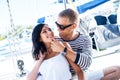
left=55, top=9, right=92, bottom=71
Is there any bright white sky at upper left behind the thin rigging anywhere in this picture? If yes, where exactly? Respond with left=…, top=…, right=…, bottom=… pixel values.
left=0, top=0, right=66, bottom=33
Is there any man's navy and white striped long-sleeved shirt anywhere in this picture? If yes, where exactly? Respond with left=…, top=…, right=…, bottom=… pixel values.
left=55, top=34, right=92, bottom=71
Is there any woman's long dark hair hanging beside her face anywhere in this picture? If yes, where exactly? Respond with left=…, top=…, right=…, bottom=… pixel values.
left=32, top=24, right=47, bottom=60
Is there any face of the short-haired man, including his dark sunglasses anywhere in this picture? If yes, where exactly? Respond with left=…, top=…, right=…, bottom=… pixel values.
left=55, top=17, right=74, bottom=38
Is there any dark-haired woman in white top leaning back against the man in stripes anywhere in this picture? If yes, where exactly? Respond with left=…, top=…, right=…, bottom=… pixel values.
left=27, top=24, right=83, bottom=80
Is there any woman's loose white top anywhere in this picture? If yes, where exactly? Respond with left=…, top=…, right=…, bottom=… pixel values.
left=37, top=54, right=72, bottom=80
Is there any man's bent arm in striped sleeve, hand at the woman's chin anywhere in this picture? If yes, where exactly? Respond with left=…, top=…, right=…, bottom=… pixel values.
left=53, top=35, right=92, bottom=70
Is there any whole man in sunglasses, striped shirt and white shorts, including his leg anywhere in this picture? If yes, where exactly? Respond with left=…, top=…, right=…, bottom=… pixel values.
left=52, top=9, right=120, bottom=80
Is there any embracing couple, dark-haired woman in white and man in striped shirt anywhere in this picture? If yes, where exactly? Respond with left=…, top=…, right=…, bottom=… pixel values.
left=27, top=9, right=120, bottom=80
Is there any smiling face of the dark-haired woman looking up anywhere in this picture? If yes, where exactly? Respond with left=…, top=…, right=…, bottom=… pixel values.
left=40, top=25, right=54, bottom=43
